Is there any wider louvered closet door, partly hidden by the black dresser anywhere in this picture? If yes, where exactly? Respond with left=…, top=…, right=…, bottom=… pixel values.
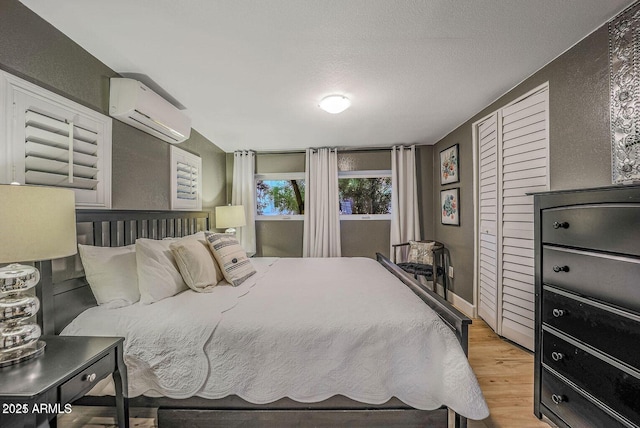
left=500, top=87, right=549, bottom=349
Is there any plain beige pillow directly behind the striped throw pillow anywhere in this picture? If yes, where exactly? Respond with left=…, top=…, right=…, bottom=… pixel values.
left=169, top=234, right=224, bottom=292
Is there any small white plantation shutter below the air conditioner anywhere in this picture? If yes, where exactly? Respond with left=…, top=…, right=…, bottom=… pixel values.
left=170, top=146, right=202, bottom=211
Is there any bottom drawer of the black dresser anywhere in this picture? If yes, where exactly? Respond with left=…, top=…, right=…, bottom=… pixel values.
left=541, top=370, right=626, bottom=428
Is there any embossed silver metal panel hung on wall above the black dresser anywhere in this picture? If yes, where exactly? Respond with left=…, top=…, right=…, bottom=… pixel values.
left=609, top=3, right=640, bottom=184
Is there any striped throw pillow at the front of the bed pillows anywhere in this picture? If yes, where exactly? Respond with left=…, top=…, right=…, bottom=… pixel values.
left=205, top=232, right=256, bottom=287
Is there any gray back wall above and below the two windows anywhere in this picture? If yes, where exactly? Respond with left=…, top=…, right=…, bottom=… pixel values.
left=252, top=150, right=391, bottom=258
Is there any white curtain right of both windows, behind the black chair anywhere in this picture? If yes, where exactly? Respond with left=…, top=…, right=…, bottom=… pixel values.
left=390, top=146, right=420, bottom=257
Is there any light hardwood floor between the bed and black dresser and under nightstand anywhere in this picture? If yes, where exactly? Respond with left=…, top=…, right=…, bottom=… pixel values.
left=58, top=319, right=549, bottom=428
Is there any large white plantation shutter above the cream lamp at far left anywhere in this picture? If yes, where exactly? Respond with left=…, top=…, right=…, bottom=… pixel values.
left=0, top=73, right=111, bottom=208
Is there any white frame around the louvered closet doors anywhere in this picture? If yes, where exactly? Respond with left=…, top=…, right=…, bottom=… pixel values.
left=472, top=82, right=551, bottom=346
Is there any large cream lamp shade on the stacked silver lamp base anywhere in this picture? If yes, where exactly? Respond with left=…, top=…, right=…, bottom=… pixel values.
left=0, top=185, right=78, bottom=263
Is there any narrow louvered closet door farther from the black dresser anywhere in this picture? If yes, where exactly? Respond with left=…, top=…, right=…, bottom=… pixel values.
left=477, top=114, right=498, bottom=330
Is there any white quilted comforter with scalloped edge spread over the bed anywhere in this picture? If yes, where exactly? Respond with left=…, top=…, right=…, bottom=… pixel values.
left=63, top=258, right=489, bottom=419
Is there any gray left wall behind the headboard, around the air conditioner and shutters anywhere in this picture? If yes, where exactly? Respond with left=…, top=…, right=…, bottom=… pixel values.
left=0, top=0, right=226, bottom=210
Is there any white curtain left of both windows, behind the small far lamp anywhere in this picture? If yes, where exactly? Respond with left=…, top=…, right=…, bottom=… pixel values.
left=231, top=151, right=256, bottom=255
